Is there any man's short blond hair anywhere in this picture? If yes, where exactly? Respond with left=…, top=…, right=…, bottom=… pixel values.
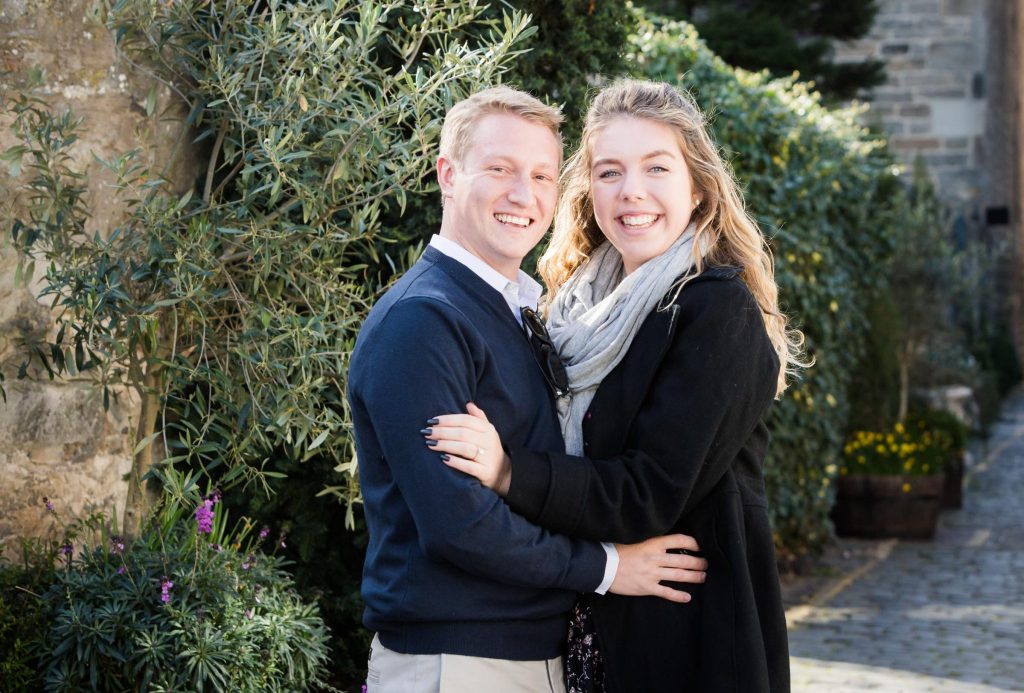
left=440, top=86, right=562, bottom=166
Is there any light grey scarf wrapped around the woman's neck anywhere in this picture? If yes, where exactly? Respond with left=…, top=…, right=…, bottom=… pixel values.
left=548, top=223, right=696, bottom=454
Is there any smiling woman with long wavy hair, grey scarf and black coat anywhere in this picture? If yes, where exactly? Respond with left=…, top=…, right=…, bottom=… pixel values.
left=419, top=80, right=803, bottom=693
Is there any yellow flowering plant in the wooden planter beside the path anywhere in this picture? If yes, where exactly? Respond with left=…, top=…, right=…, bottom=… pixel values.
left=840, top=417, right=962, bottom=476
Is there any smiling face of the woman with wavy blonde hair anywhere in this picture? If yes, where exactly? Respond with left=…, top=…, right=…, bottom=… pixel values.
left=590, top=116, right=699, bottom=274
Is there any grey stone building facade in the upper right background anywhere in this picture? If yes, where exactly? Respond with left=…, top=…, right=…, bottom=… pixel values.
left=836, top=0, right=1024, bottom=354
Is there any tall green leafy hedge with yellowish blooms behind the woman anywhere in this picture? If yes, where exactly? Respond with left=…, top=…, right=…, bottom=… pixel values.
left=631, top=12, right=903, bottom=556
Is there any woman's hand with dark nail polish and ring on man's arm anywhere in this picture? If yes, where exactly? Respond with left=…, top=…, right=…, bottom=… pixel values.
left=420, top=402, right=512, bottom=496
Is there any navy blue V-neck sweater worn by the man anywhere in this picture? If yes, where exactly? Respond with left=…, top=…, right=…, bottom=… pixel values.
left=348, top=248, right=606, bottom=659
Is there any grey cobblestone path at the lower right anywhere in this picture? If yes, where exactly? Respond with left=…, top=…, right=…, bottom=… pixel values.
left=786, top=393, right=1024, bottom=693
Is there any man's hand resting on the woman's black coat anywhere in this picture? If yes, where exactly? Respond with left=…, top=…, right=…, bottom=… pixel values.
left=608, top=534, right=708, bottom=603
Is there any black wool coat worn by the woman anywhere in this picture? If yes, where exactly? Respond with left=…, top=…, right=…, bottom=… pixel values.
left=507, top=267, right=790, bottom=693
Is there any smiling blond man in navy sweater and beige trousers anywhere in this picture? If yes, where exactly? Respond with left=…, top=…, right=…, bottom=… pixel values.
left=348, top=87, right=695, bottom=693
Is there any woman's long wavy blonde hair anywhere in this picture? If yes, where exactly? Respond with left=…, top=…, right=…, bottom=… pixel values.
left=538, top=79, right=810, bottom=395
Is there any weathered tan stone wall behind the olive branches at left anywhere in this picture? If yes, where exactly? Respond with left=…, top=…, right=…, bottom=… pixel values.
left=0, top=0, right=191, bottom=543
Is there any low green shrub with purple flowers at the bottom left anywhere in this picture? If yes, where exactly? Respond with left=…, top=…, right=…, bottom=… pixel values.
left=41, top=472, right=328, bottom=693
